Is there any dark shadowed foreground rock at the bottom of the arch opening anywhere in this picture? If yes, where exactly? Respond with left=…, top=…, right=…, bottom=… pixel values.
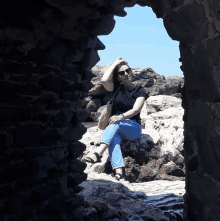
left=77, top=180, right=184, bottom=221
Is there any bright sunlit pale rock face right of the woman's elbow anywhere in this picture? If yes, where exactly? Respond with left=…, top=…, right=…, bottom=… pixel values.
left=143, top=95, right=184, bottom=158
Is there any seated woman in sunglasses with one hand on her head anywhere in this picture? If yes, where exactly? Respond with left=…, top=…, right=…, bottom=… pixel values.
left=84, top=58, right=147, bottom=180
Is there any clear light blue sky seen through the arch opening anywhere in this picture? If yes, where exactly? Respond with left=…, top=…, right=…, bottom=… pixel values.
left=97, top=5, right=183, bottom=78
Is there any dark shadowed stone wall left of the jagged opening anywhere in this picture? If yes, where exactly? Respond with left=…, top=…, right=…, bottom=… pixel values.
left=0, top=1, right=103, bottom=221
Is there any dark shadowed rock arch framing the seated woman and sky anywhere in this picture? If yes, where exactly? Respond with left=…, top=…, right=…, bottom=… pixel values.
left=0, top=0, right=220, bottom=221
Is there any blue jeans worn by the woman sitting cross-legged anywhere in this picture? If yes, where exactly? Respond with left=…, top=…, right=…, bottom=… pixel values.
left=101, top=120, right=142, bottom=169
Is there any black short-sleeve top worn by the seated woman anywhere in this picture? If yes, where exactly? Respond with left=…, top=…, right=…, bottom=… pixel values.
left=112, top=83, right=148, bottom=123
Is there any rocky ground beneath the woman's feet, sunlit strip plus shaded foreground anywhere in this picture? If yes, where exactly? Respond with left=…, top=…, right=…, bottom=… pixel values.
left=78, top=179, right=185, bottom=221
